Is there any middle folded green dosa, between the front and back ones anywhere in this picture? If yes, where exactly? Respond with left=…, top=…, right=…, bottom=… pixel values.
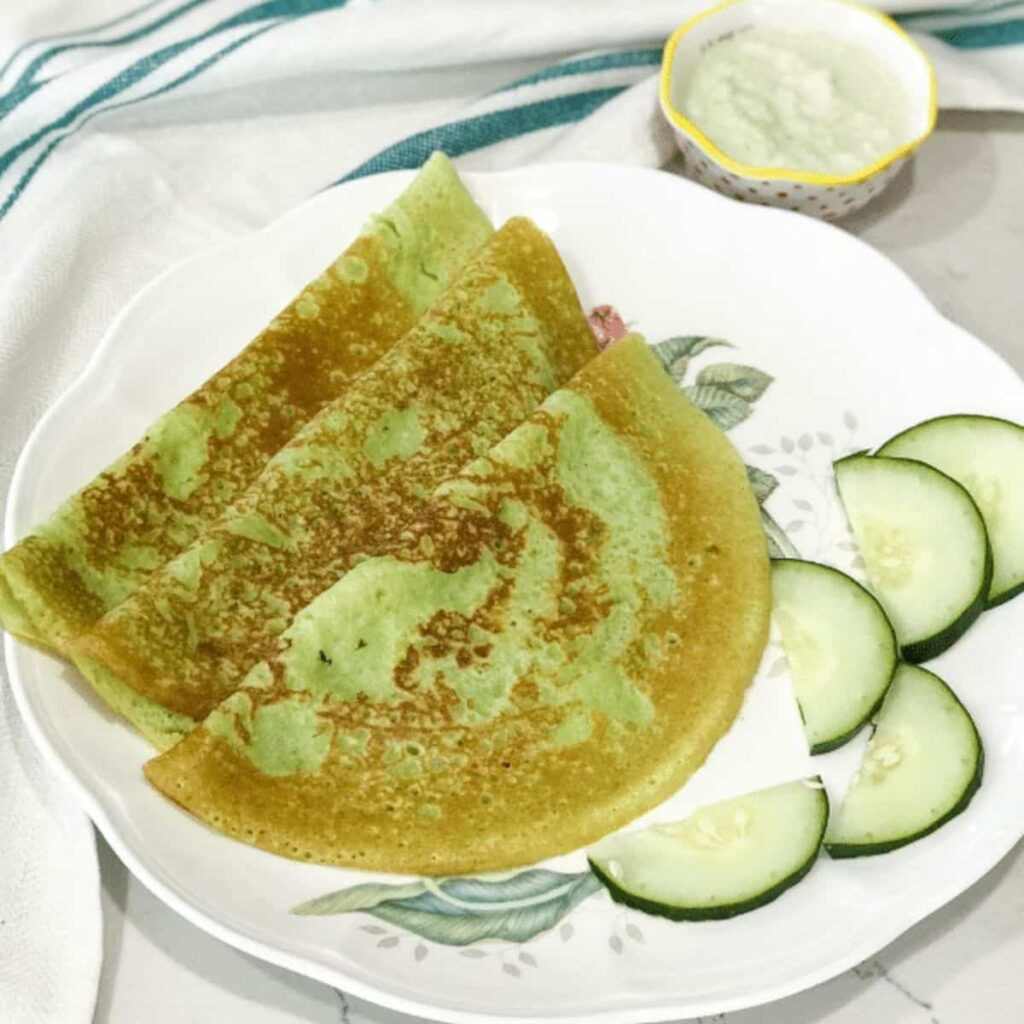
left=71, top=218, right=594, bottom=746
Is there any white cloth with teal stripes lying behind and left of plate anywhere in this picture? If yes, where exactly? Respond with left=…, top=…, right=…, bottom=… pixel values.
left=0, top=0, right=1024, bottom=1024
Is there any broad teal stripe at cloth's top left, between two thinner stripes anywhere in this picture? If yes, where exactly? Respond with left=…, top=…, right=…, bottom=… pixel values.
left=0, top=0, right=347, bottom=180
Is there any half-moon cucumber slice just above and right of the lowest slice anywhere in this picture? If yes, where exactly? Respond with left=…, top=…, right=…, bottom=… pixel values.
left=825, top=665, right=985, bottom=857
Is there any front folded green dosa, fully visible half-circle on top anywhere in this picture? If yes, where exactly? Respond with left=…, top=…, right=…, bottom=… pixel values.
left=145, top=339, right=770, bottom=874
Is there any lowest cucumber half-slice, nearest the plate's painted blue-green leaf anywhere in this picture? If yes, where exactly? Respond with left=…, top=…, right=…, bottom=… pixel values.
left=588, top=778, right=828, bottom=921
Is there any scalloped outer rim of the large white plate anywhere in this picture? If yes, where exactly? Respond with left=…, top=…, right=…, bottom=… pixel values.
left=4, top=163, right=1024, bottom=1024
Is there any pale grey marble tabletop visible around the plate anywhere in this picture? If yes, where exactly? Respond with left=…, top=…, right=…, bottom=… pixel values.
left=95, top=108, right=1024, bottom=1024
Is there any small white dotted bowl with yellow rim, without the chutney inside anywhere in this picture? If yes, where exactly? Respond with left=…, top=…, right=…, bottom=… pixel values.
left=660, top=0, right=936, bottom=220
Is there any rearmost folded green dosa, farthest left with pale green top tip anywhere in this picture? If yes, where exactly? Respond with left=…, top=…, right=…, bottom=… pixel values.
left=0, top=155, right=492, bottom=652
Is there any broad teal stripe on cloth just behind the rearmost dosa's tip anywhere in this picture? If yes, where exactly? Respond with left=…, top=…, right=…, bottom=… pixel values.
left=328, top=85, right=626, bottom=188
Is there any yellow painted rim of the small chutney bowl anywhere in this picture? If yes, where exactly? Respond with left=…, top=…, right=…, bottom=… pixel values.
left=660, top=0, right=937, bottom=185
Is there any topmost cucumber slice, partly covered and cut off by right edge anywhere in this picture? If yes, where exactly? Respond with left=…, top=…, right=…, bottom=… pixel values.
left=878, top=415, right=1024, bottom=608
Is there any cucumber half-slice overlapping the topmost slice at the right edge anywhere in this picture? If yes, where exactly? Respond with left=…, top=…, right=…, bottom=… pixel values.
left=835, top=455, right=992, bottom=662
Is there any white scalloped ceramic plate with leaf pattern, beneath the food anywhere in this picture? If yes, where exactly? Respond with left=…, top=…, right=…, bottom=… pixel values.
left=6, top=165, right=1024, bottom=1024
